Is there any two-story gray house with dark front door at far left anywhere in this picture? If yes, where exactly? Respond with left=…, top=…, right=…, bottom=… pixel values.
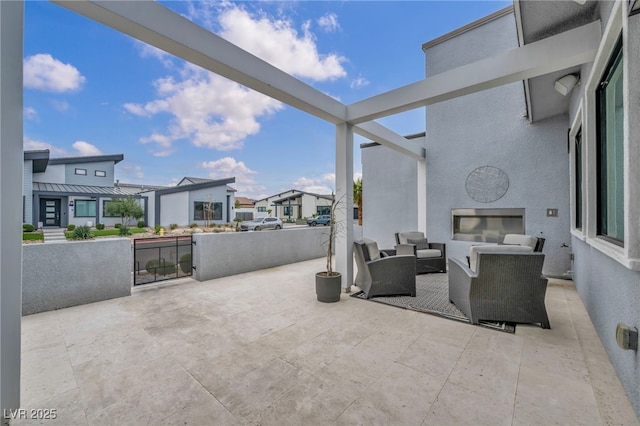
left=23, top=150, right=151, bottom=227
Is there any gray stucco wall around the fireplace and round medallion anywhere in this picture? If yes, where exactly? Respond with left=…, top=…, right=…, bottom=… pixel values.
left=362, top=14, right=571, bottom=276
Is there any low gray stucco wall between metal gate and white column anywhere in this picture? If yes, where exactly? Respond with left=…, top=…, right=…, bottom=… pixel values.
left=193, top=227, right=327, bottom=281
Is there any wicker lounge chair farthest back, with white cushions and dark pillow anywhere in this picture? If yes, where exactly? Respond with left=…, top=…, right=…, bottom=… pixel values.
left=395, top=231, right=447, bottom=274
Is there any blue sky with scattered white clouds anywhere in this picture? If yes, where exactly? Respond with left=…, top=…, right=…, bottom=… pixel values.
left=24, top=1, right=511, bottom=199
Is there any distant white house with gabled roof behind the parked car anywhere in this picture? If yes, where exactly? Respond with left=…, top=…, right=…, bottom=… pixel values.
left=255, top=189, right=331, bottom=220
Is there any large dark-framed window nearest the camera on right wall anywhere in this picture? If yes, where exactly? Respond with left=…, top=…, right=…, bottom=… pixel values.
left=596, top=38, right=624, bottom=246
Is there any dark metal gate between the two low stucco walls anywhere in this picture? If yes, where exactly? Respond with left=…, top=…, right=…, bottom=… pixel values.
left=133, top=235, right=193, bottom=286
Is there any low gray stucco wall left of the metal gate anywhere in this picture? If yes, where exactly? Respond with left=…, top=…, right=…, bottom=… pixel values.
left=22, top=238, right=133, bottom=315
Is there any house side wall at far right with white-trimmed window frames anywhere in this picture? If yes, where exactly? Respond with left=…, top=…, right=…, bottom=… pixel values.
left=568, top=2, right=640, bottom=417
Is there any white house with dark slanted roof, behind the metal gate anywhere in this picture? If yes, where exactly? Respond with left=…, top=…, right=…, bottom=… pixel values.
left=141, top=177, right=236, bottom=226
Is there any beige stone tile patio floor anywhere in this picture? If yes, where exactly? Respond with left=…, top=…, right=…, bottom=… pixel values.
left=17, top=259, right=639, bottom=425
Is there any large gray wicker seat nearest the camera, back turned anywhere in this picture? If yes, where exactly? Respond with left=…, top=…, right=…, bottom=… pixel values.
left=449, top=251, right=551, bottom=328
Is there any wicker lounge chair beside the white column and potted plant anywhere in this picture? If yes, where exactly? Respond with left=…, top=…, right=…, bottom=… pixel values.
left=353, top=239, right=416, bottom=299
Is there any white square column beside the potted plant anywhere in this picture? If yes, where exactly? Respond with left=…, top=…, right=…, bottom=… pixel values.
left=336, top=123, right=353, bottom=293
